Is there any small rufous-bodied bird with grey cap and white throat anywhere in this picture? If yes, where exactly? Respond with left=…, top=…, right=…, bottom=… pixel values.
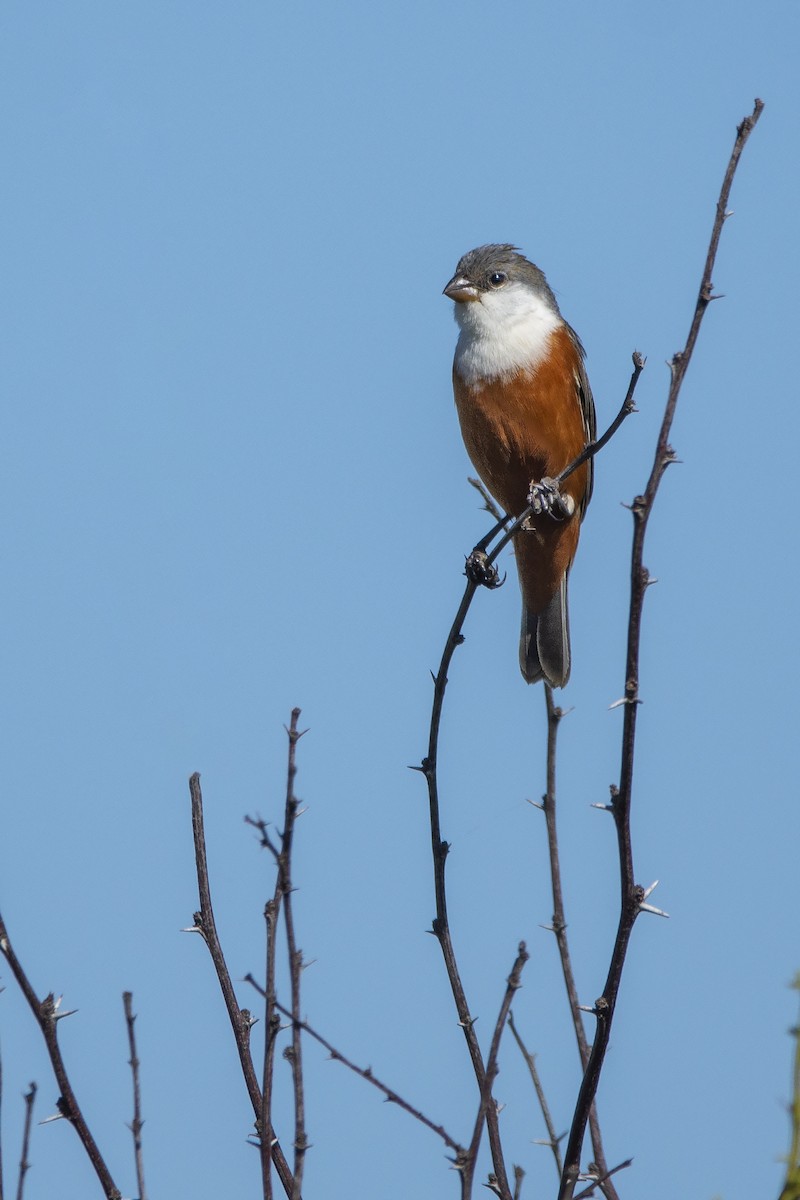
left=444, top=245, right=596, bottom=688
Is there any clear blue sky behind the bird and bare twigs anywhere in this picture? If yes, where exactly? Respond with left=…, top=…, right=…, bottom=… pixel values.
left=0, top=0, right=800, bottom=1200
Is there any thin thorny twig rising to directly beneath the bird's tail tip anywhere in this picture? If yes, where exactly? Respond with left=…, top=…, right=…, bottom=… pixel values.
left=542, top=683, right=619, bottom=1200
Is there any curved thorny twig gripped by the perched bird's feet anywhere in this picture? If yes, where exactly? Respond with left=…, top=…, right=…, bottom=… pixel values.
left=414, top=354, right=644, bottom=1200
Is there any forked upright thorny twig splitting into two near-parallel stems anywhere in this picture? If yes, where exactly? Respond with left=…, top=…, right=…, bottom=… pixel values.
left=245, top=708, right=308, bottom=1200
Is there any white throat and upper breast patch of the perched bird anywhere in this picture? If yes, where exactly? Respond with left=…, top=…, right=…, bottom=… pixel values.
left=455, top=282, right=564, bottom=386
